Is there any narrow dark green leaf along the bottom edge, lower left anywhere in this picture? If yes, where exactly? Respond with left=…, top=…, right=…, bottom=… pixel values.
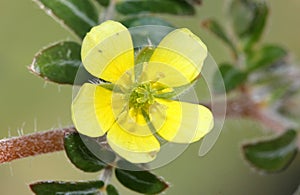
left=30, top=181, right=104, bottom=195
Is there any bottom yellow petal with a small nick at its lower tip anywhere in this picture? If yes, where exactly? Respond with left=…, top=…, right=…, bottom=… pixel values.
left=107, top=123, right=160, bottom=163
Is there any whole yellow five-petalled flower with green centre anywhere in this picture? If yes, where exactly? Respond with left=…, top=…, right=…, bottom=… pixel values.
left=72, top=21, right=213, bottom=163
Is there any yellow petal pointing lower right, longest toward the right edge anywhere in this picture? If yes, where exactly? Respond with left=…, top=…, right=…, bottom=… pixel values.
left=153, top=98, right=213, bottom=143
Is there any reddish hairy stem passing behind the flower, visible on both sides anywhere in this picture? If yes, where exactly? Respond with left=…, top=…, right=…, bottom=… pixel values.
left=0, top=95, right=300, bottom=163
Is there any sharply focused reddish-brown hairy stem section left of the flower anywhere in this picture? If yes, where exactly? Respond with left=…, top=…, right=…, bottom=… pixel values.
left=0, top=127, right=76, bottom=163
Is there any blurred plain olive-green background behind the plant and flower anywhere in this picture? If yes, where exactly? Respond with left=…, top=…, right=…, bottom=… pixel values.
left=0, top=0, right=300, bottom=195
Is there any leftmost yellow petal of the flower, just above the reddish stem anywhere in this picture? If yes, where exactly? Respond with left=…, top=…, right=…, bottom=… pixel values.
left=72, top=83, right=121, bottom=137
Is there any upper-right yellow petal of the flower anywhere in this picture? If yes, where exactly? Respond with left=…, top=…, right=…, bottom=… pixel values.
left=149, top=28, right=207, bottom=86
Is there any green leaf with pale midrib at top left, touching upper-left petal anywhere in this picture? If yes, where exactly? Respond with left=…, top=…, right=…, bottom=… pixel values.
left=35, top=0, right=98, bottom=38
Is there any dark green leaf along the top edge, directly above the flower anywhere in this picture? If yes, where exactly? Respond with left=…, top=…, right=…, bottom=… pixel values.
left=116, top=0, right=195, bottom=15
